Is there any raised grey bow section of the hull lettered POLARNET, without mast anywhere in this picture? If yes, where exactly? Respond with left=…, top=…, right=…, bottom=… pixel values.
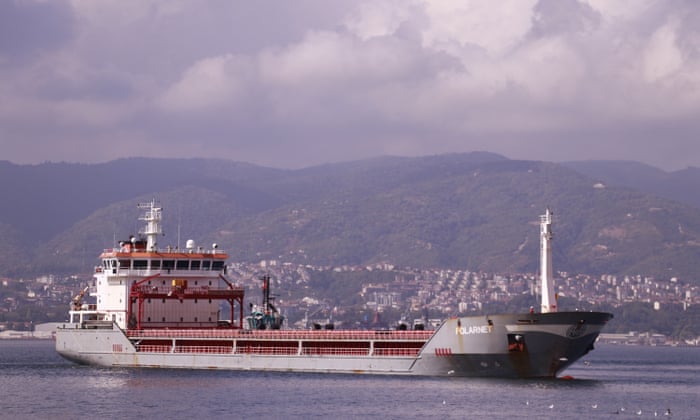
left=413, top=312, right=612, bottom=378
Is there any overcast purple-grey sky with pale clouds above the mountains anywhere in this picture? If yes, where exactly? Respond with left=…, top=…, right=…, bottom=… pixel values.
left=0, top=0, right=700, bottom=170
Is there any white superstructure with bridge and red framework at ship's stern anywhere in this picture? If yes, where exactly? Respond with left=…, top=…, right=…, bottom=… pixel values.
left=70, top=200, right=242, bottom=329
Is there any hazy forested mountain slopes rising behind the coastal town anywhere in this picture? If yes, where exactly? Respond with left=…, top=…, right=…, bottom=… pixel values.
left=0, top=152, right=700, bottom=281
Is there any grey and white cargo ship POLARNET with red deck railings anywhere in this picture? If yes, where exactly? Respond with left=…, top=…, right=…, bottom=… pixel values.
left=56, top=200, right=612, bottom=378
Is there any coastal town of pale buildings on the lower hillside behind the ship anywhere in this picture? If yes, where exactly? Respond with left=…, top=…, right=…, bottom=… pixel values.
left=0, top=260, right=700, bottom=345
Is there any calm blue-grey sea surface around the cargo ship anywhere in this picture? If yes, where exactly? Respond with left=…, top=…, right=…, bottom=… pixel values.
left=0, top=340, right=700, bottom=420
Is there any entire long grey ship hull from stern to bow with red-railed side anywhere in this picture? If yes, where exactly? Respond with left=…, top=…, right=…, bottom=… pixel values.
left=56, top=312, right=612, bottom=378
